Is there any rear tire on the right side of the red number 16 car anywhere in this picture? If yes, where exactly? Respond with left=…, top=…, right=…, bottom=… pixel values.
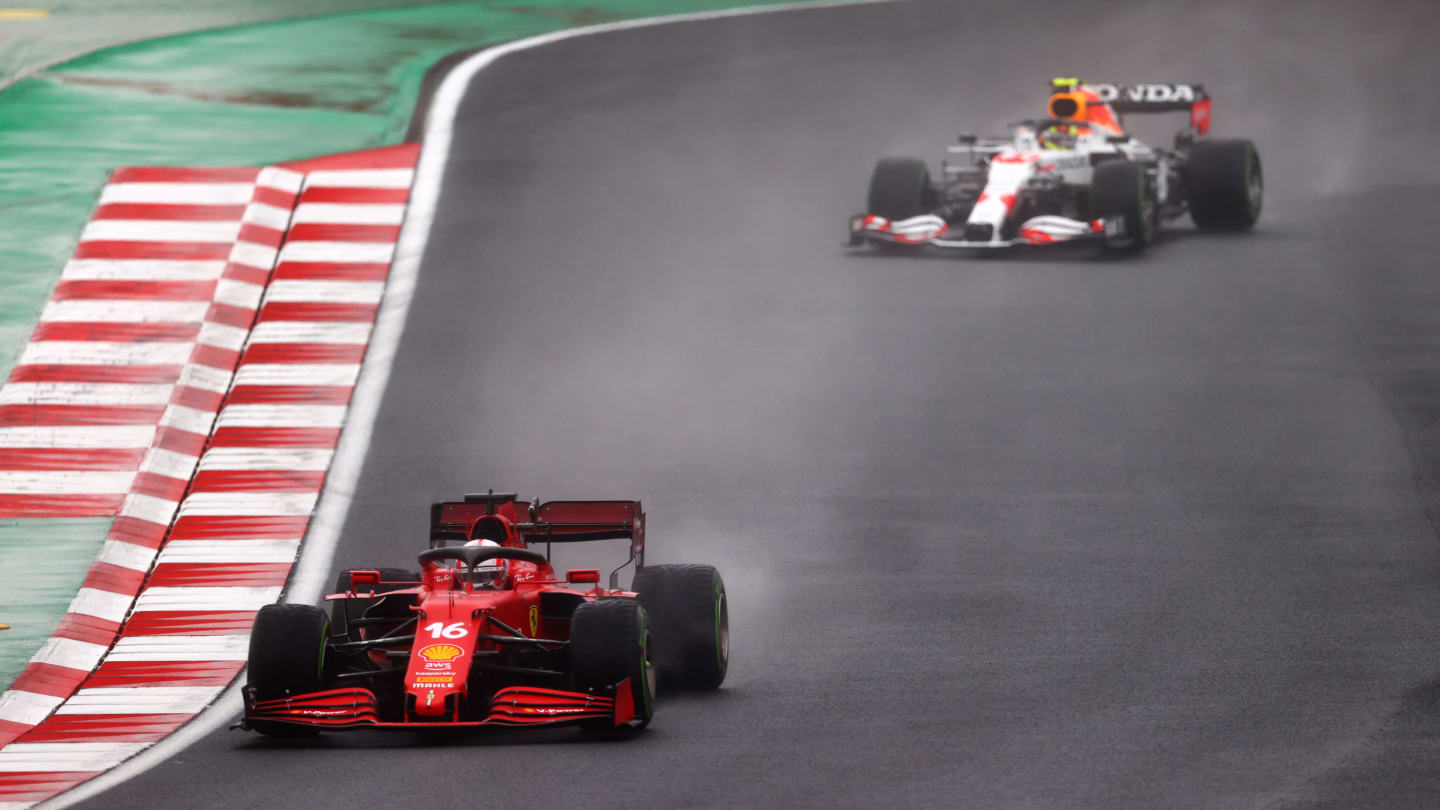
left=631, top=565, right=730, bottom=690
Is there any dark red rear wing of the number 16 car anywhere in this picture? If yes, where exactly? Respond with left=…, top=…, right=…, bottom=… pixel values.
left=431, top=493, right=645, bottom=565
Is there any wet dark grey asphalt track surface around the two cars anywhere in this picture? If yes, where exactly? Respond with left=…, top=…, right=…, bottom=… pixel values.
left=78, top=0, right=1440, bottom=809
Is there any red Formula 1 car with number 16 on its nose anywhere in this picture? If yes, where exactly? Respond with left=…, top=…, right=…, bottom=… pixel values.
left=240, top=493, right=730, bottom=735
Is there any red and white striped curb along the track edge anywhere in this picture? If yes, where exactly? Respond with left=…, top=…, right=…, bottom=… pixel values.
left=0, top=146, right=419, bottom=810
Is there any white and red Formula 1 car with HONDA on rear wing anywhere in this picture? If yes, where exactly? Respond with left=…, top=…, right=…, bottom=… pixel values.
left=850, top=79, right=1264, bottom=252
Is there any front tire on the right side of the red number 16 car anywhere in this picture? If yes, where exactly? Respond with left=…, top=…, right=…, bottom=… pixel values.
left=570, top=598, right=655, bottom=729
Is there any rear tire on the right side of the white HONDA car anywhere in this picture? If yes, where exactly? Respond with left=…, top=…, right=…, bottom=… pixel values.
left=1185, top=138, right=1264, bottom=231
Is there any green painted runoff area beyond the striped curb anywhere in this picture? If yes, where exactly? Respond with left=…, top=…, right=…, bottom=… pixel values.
left=0, top=0, right=777, bottom=700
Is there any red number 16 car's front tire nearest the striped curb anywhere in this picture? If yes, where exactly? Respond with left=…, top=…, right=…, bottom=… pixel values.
left=246, top=604, right=330, bottom=736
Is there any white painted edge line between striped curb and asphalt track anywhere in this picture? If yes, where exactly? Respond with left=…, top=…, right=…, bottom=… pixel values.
left=43, top=0, right=901, bottom=810
